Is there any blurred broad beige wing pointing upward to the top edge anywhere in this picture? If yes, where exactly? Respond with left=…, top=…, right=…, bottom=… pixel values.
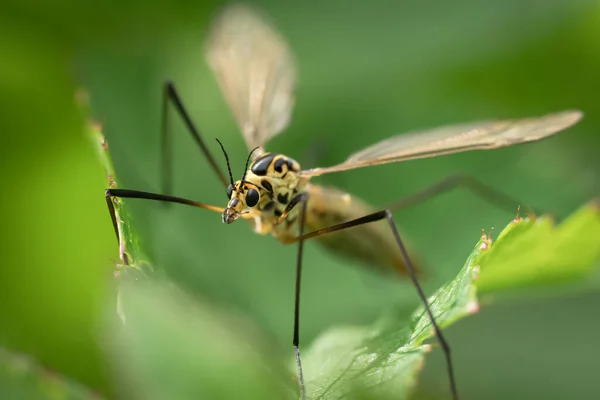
left=206, top=5, right=296, bottom=155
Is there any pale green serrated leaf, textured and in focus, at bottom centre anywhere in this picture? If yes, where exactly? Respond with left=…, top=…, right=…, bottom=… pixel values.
left=304, top=236, right=490, bottom=399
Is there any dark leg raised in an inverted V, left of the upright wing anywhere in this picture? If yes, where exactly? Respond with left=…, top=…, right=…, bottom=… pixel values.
left=162, top=81, right=229, bottom=194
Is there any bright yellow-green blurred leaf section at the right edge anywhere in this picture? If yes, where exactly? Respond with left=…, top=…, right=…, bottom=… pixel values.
left=477, top=201, right=600, bottom=294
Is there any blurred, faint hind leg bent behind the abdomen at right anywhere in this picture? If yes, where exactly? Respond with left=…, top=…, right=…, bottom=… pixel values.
left=387, top=174, right=535, bottom=214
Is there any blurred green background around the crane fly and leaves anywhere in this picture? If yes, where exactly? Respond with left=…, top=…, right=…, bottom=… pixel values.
left=0, top=0, right=600, bottom=399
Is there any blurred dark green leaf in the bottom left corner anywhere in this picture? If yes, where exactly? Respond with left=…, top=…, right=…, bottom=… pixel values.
left=0, top=348, right=101, bottom=400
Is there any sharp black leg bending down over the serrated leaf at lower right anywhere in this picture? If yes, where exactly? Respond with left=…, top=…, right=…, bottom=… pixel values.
left=295, top=209, right=458, bottom=400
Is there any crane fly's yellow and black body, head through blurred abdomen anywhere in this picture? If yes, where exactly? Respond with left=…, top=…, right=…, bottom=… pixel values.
left=223, top=153, right=415, bottom=275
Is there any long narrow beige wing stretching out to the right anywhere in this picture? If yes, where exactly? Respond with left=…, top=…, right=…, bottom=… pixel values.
left=301, top=110, right=583, bottom=176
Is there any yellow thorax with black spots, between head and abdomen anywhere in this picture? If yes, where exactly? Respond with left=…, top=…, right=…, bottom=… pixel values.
left=246, top=153, right=308, bottom=236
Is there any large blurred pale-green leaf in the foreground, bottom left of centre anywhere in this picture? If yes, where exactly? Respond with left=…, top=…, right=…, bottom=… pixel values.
left=106, top=279, right=297, bottom=400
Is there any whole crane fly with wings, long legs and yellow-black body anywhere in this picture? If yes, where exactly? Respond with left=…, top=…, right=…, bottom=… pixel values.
left=106, top=5, right=582, bottom=399
